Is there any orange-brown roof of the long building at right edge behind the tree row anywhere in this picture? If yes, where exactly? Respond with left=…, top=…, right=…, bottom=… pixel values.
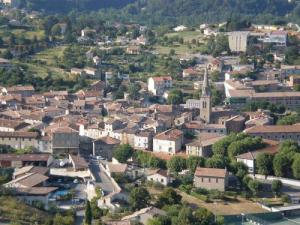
left=245, top=125, right=300, bottom=134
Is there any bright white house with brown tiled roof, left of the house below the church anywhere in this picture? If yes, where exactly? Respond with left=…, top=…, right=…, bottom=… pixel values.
left=153, top=129, right=183, bottom=154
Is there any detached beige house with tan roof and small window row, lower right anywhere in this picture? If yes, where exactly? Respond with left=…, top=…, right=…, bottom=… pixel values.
left=194, top=167, right=229, bottom=191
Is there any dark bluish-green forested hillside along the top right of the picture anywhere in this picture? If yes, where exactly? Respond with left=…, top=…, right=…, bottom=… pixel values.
left=122, top=0, right=297, bottom=24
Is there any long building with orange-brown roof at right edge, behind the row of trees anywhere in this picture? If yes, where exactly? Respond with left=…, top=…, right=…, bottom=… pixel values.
left=244, top=124, right=300, bottom=143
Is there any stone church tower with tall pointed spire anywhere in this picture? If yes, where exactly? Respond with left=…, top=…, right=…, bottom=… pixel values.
left=200, top=68, right=211, bottom=123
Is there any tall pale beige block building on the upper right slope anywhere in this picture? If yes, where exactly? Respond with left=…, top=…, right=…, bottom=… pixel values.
left=228, top=31, right=249, bottom=52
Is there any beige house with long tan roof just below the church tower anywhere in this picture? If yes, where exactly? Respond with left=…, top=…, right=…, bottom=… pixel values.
left=186, top=133, right=225, bottom=157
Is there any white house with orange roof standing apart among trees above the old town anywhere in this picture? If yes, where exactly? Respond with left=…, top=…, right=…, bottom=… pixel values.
left=148, top=76, right=172, bottom=96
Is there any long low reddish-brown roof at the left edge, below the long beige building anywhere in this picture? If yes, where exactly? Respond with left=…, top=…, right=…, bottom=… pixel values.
left=0, top=154, right=51, bottom=162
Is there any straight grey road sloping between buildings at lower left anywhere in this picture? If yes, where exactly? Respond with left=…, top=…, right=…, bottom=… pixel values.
left=89, top=160, right=114, bottom=194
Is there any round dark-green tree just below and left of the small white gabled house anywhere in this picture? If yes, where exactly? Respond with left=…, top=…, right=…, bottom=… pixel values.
left=129, top=187, right=151, bottom=210
